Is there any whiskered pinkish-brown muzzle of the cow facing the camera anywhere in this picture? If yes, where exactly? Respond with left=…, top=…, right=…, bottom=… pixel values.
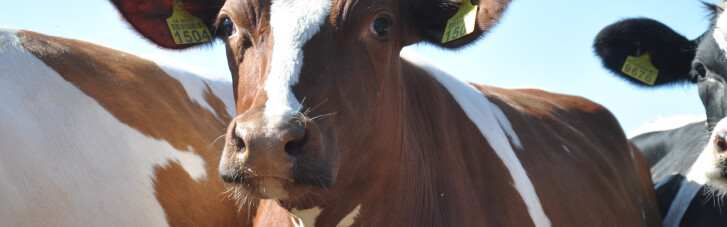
left=219, top=109, right=332, bottom=199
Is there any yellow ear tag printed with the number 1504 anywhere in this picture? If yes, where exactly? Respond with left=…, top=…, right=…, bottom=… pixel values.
left=167, top=0, right=212, bottom=44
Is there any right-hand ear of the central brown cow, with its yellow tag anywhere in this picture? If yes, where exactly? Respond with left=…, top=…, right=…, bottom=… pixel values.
left=408, top=0, right=510, bottom=49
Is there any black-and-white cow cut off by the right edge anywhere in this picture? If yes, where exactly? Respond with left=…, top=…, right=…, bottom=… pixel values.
left=594, top=3, right=727, bottom=226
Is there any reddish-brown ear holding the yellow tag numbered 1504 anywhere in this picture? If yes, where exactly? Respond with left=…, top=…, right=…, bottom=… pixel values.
left=111, top=0, right=224, bottom=49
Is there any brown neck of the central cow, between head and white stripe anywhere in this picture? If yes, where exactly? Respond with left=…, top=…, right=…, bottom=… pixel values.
left=366, top=60, right=532, bottom=226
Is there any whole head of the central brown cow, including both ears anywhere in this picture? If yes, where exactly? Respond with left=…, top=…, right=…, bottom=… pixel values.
left=113, top=0, right=509, bottom=207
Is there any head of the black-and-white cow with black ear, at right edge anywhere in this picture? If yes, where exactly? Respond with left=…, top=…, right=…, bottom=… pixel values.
left=593, top=3, right=727, bottom=130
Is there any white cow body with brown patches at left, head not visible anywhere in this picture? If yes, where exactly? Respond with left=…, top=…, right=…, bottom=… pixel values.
left=0, top=29, right=254, bottom=226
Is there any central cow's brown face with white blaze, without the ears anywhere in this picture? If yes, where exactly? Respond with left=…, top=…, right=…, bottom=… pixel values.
left=217, top=0, right=411, bottom=201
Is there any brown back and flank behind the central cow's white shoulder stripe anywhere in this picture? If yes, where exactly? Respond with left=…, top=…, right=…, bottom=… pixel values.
left=477, top=86, right=660, bottom=226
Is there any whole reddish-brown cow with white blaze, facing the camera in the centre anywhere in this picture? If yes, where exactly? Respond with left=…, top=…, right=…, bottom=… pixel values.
left=113, top=0, right=659, bottom=226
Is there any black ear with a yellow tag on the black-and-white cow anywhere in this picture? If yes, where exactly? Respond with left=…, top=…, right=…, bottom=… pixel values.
left=593, top=18, right=696, bottom=87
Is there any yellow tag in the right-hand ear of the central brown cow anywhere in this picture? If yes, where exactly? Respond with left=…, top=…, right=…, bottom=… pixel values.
left=442, top=0, right=477, bottom=43
